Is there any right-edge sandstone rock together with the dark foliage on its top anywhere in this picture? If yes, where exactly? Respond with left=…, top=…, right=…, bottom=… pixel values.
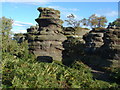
left=101, top=18, right=120, bottom=60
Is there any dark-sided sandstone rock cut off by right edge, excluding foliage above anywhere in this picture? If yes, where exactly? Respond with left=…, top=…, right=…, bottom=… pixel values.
left=103, top=28, right=120, bottom=60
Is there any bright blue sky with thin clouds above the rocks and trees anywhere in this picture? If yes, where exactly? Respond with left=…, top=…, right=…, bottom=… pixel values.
left=2, top=2, right=118, bottom=33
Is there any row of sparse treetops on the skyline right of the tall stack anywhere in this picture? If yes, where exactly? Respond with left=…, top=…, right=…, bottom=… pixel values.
left=65, top=14, right=107, bottom=28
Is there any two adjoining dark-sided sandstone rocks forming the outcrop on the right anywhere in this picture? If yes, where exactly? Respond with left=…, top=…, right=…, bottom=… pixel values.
left=83, top=27, right=120, bottom=60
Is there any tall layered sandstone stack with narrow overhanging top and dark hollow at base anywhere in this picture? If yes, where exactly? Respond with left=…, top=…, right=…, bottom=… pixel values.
left=27, top=7, right=66, bottom=61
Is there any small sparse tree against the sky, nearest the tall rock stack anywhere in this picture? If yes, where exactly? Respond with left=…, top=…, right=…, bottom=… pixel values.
left=65, top=14, right=81, bottom=27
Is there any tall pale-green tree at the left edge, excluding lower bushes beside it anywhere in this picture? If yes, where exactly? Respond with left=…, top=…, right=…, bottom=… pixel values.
left=0, top=17, right=13, bottom=52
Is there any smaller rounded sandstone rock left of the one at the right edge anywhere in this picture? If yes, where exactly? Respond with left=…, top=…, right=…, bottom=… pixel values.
left=83, top=30, right=105, bottom=53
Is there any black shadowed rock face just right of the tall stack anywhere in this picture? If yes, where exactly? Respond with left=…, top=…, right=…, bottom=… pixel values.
left=62, top=37, right=84, bottom=66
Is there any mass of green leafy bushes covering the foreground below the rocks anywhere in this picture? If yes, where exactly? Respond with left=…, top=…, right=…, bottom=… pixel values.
left=3, top=55, right=117, bottom=88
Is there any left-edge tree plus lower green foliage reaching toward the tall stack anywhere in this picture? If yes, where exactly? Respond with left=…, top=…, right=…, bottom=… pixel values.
left=0, top=17, right=29, bottom=59
